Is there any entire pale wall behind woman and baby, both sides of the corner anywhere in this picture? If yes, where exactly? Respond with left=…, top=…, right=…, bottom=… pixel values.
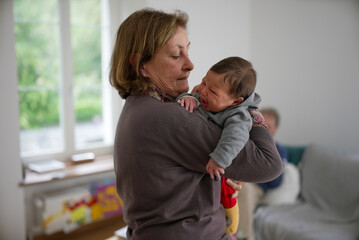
left=123, top=0, right=359, bottom=153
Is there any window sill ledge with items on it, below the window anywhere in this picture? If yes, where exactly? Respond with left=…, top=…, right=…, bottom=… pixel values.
left=20, top=155, right=114, bottom=187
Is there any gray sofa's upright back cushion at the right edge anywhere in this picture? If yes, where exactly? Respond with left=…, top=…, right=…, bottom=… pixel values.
left=300, top=144, right=359, bottom=222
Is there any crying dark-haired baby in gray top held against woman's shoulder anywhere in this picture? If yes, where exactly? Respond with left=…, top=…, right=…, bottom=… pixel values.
left=176, top=57, right=261, bottom=234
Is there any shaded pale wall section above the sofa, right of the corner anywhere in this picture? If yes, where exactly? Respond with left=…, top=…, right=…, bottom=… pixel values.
left=250, top=0, right=359, bottom=153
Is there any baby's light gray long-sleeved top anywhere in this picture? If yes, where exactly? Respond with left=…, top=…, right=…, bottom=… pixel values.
left=176, top=92, right=261, bottom=168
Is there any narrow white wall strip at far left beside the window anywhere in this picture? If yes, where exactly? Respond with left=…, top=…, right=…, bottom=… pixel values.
left=0, top=0, right=25, bottom=240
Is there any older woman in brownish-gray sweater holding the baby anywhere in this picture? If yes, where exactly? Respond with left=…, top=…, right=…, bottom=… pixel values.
left=110, top=9, right=282, bottom=240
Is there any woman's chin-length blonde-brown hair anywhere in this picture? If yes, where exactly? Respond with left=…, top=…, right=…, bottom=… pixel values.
left=109, top=8, right=188, bottom=99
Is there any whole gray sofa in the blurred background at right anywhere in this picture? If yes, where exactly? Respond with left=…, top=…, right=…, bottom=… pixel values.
left=254, top=144, right=359, bottom=240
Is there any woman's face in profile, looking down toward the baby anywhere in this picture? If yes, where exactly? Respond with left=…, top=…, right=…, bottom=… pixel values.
left=141, top=27, right=193, bottom=98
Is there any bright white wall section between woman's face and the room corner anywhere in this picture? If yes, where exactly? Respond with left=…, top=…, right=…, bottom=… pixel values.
left=138, top=0, right=250, bottom=88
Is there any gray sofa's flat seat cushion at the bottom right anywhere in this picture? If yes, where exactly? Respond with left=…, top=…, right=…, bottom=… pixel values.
left=254, top=202, right=359, bottom=240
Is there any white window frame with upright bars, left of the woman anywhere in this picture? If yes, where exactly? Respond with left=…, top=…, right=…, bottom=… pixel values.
left=21, top=0, right=123, bottom=164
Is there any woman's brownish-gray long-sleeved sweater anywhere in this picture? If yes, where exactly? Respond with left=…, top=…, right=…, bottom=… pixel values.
left=114, top=96, right=282, bottom=240
